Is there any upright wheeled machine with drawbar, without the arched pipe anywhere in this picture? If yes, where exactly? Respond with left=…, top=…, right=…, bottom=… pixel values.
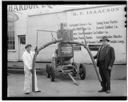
left=46, top=24, right=86, bottom=85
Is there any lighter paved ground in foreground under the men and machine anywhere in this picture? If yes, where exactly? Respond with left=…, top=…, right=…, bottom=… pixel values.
left=8, top=73, right=127, bottom=97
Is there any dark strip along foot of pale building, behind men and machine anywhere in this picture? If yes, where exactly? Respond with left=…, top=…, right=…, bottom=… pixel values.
left=8, top=62, right=127, bottom=80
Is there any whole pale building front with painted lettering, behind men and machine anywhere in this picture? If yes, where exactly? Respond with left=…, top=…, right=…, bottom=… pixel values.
left=8, top=5, right=126, bottom=64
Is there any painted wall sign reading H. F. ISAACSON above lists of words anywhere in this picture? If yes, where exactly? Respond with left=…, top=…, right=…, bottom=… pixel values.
left=67, top=6, right=126, bottom=44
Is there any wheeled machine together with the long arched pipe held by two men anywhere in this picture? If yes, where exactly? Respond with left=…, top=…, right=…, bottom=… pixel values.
left=32, top=24, right=101, bottom=92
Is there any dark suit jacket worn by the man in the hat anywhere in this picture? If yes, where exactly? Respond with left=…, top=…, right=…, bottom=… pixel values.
left=94, top=45, right=115, bottom=69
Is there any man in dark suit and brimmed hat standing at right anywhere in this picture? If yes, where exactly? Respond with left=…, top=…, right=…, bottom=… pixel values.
left=94, top=36, right=115, bottom=93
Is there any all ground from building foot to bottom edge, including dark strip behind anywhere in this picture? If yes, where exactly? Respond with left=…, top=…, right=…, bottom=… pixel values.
left=8, top=62, right=127, bottom=97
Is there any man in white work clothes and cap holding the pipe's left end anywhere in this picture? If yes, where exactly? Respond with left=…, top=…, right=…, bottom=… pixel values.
left=22, top=44, right=41, bottom=94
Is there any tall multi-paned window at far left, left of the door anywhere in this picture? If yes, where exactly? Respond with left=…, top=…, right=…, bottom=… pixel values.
left=8, top=22, right=15, bottom=50
